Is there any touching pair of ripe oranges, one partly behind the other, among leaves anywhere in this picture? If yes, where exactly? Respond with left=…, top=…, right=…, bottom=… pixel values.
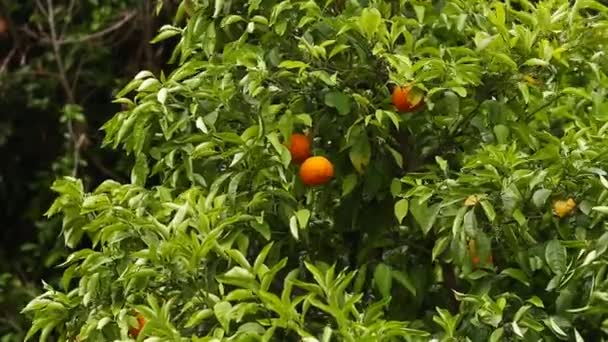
left=286, top=133, right=334, bottom=186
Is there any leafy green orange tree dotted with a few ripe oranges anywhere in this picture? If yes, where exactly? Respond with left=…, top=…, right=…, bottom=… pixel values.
left=24, top=0, right=608, bottom=342
